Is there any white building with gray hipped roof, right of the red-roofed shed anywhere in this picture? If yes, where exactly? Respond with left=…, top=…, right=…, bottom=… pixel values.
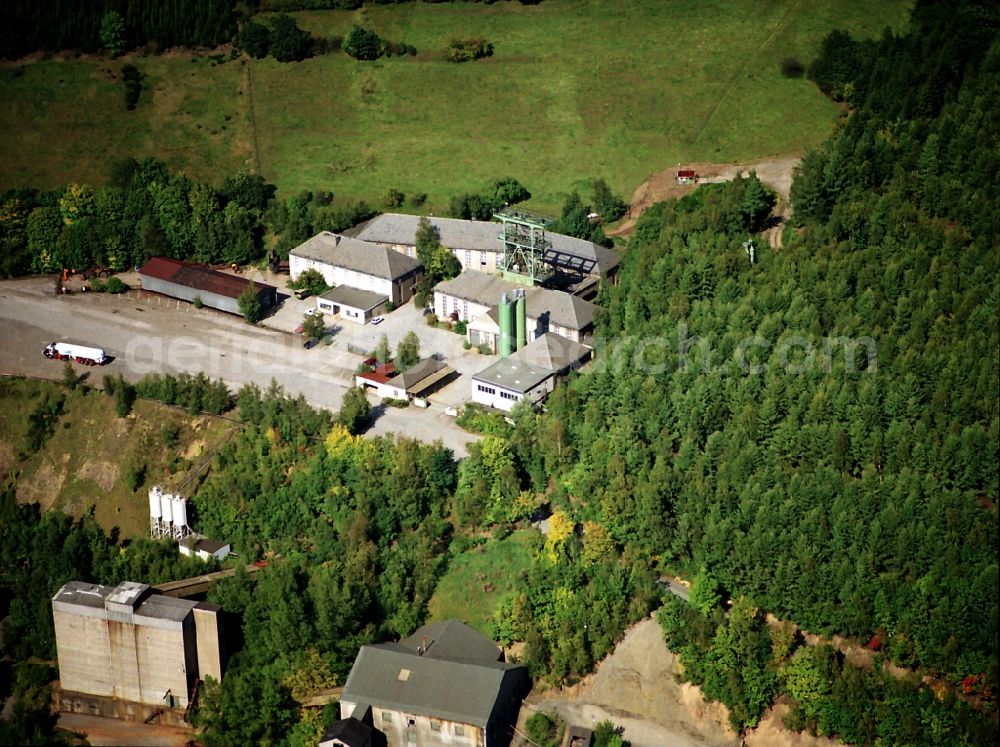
left=288, top=231, right=423, bottom=306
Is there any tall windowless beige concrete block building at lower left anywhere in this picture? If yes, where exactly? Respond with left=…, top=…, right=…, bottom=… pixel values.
left=52, top=581, right=224, bottom=721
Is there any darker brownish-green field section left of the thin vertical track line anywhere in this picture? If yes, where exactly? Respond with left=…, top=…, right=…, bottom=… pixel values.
left=0, top=55, right=252, bottom=190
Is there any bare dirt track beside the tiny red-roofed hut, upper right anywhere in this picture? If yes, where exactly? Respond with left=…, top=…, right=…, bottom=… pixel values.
left=608, top=155, right=802, bottom=246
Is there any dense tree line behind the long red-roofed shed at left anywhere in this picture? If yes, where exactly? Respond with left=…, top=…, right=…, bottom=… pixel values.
left=0, top=158, right=375, bottom=277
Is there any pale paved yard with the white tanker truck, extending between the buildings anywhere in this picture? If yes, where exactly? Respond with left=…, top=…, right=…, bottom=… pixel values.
left=0, top=278, right=490, bottom=456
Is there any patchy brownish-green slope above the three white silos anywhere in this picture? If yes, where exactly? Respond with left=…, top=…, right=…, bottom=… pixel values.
left=0, top=380, right=234, bottom=537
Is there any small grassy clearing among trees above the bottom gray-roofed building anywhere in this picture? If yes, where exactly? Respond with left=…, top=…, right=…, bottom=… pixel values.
left=427, top=529, right=536, bottom=636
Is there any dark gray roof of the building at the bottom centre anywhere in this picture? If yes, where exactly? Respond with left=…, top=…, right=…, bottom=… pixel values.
left=341, top=621, right=520, bottom=727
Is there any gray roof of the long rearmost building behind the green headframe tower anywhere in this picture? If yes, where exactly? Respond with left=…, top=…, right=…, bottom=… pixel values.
left=344, top=213, right=619, bottom=274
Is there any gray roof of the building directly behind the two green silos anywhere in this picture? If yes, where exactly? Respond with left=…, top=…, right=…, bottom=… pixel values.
left=434, top=270, right=597, bottom=330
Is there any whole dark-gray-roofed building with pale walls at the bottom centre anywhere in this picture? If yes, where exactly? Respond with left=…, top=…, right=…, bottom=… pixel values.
left=340, top=620, right=529, bottom=747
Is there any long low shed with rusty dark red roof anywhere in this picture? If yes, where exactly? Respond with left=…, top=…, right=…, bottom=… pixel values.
left=139, top=257, right=278, bottom=314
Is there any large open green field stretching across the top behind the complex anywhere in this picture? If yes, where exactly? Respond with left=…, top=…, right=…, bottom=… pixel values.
left=0, top=0, right=910, bottom=210
